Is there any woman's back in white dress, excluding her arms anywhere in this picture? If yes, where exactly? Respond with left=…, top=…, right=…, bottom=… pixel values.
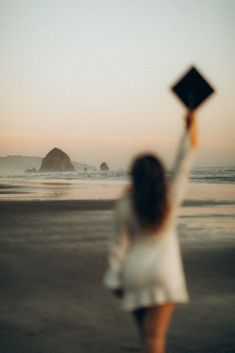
left=114, top=186, right=188, bottom=311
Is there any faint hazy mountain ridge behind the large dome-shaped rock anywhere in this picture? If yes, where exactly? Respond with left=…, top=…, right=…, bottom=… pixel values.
left=0, top=155, right=96, bottom=174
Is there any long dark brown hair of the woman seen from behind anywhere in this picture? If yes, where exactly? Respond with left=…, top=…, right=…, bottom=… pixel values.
left=131, top=154, right=168, bottom=230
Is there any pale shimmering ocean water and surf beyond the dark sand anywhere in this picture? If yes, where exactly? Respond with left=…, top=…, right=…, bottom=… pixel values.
left=0, top=167, right=235, bottom=204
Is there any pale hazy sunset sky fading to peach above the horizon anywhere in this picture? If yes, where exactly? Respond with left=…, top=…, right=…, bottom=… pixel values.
left=0, top=0, right=235, bottom=169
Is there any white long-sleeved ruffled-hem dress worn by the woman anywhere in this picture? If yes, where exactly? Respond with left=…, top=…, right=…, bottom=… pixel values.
left=104, top=132, right=192, bottom=311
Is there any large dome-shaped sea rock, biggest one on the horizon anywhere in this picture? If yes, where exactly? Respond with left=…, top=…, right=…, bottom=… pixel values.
left=39, top=147, right=75, bottom=172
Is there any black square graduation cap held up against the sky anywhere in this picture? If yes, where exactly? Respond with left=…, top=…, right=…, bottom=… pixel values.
left=172, top=66, right=214, bottom=110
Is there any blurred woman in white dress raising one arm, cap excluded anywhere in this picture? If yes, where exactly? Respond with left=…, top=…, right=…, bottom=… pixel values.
left=105, top=112, right=196, bottom=353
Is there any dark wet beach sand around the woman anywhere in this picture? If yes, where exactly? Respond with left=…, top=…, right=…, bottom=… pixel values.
left=0, top=201, right=235, bottom=353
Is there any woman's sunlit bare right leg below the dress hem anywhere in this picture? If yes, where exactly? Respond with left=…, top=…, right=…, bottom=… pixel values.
left=144, top=303, right=174, bottom=353
